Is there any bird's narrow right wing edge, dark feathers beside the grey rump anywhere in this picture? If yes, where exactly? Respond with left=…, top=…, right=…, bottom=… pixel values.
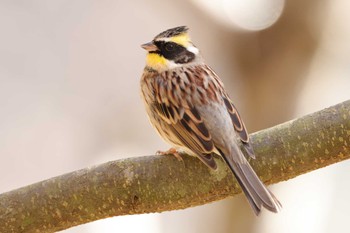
left=222, top=96, right=255, bottom=159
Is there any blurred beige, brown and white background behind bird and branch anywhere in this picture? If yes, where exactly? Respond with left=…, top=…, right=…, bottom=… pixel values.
left=0, top=0, right=350, bottom=233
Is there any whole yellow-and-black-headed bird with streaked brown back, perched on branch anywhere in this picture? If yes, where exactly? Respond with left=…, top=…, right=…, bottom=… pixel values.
left=140, top=26, right=282, bottom=215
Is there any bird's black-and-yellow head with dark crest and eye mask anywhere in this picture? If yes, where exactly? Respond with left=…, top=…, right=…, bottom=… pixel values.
left=141, top=26, right=199, bottom=71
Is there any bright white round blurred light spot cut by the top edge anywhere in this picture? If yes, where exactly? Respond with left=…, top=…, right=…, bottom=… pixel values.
left=193, top=0, right=285, bottom=31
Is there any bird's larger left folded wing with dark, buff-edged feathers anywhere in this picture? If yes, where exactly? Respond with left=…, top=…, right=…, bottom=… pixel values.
left=154, top=103, right=217, bottom=169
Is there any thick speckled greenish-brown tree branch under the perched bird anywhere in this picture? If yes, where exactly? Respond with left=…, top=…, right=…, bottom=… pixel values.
left=0, top=100, right=350, bottom=232
